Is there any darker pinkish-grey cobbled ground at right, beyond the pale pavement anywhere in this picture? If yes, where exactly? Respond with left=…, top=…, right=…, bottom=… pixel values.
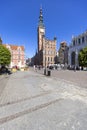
left=37, top=70, right=87, bottom=88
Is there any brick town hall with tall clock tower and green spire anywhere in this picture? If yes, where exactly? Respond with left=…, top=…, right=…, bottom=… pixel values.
left=37, top=8, right=56, bottom=67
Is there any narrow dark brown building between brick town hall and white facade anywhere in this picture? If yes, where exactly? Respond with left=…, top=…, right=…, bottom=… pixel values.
left=59, top=41, right=68, bottom=64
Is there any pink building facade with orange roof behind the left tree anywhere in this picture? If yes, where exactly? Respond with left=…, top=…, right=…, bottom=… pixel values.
left=4, top=44, right=25, bottom=68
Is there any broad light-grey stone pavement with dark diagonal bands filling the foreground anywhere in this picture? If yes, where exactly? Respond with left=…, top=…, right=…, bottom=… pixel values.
left=0, top=70, right=87, bottom=130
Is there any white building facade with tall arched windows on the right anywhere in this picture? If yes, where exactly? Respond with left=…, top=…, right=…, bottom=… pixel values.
left=68, top=31, right=87, bottom=66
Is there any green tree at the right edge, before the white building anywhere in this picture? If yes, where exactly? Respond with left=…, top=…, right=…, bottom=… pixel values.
left=78, top=47, right=87, bottom=67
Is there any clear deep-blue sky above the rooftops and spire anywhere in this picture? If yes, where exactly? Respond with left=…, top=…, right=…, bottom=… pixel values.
left=0, top=0, right=87, bottom=58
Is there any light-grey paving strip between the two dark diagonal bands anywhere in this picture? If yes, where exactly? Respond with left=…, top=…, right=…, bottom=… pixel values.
left=0, top=92, right=61, bottom=121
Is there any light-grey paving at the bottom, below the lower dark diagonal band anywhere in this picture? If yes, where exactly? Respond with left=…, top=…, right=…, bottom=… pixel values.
left=0, top=99, right=87, bottom=130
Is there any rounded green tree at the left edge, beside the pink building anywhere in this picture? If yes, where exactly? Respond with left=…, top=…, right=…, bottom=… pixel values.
left=0, top=45, right=11, bottom=66
